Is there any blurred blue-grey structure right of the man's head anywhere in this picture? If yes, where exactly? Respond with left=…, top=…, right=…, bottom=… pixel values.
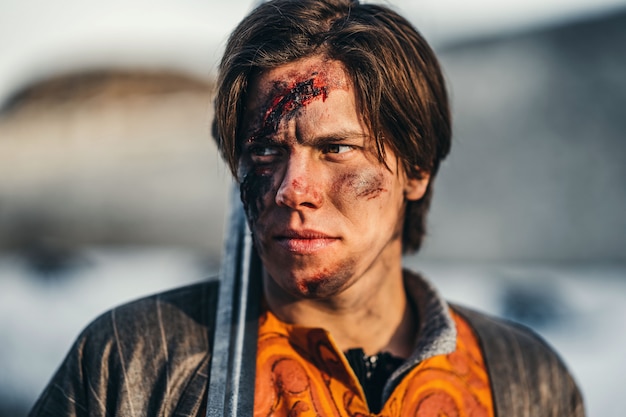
left=423, top=9, right=626, bottom=263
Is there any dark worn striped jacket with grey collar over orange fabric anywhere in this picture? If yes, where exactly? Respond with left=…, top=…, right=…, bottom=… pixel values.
left=29, top=273, right=584, bottom=417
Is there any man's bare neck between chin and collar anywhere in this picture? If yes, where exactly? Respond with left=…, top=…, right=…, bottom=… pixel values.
left=264, top=265, right=417, bottom=358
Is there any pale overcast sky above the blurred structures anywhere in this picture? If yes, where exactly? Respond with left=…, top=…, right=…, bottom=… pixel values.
left=0, top=0, right=626, bottom=102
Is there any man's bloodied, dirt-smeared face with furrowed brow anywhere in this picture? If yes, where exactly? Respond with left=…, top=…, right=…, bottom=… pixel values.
left=239, top=57, right=428, bottom=299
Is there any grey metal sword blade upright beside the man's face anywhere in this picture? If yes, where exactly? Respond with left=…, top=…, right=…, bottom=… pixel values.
left=207, top=186, right=261, bottom=417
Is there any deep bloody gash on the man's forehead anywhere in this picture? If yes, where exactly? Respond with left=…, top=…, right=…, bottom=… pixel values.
left=249, top=72, right=328, bottom=141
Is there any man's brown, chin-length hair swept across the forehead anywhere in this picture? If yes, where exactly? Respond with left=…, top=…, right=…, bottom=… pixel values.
left=213, top=0, right=451, bottom=252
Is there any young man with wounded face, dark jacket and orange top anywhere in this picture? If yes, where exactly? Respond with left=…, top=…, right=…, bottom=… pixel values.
left=31, top=0, right=584, bottom=416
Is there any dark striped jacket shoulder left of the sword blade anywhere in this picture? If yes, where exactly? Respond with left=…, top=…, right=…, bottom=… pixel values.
left=29, top=281, right=218, bottom=417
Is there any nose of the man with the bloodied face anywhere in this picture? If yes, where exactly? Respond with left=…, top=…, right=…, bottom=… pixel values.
left=276, top=155, right=323, bottom=210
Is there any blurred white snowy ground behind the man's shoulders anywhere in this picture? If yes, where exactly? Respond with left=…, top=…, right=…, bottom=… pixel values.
left=0, top=248, right=626, bottom=417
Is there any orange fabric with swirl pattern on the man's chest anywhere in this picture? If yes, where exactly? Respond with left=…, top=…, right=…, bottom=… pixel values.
left=254, top=311, right=494, bottom=417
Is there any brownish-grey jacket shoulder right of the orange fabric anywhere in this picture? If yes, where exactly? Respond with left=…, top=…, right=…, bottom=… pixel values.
left=451, top=305, right=584, bottom=416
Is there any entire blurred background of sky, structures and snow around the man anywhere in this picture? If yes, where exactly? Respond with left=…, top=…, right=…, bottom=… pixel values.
left=0, top=0, right=626, bottom=417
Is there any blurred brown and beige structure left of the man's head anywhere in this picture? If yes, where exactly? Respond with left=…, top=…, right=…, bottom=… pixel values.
left=0, top=70, right=229, bottom=276
